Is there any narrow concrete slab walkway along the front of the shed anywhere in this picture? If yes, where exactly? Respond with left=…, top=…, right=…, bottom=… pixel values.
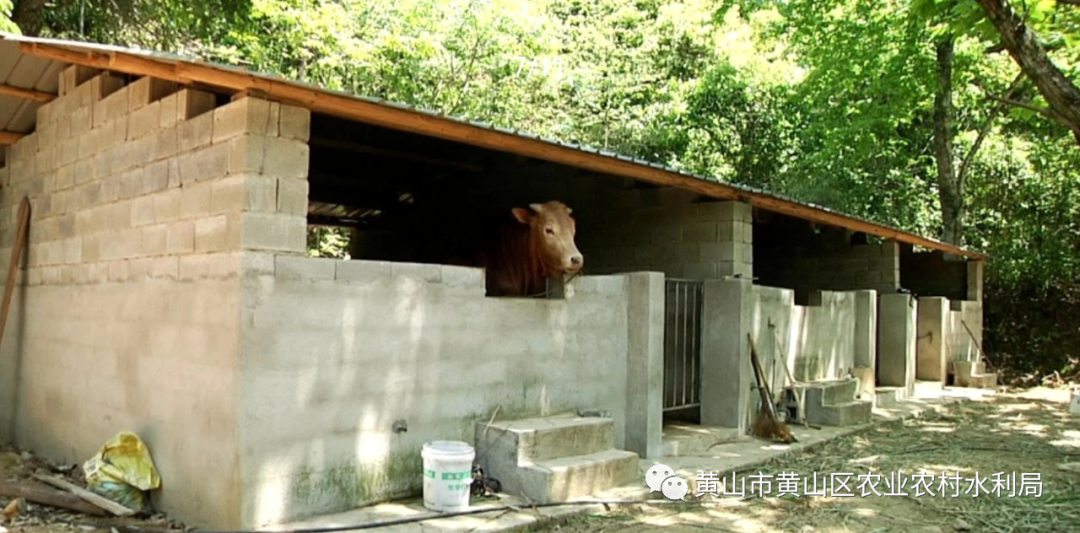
left=267, top=387, right=995, bottom=533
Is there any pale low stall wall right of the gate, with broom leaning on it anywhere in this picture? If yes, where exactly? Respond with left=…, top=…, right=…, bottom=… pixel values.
left=752, top=285, right=855, bottom=391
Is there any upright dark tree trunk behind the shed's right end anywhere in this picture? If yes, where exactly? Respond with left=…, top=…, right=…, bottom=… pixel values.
left=934, top=36, right=963, bottom=246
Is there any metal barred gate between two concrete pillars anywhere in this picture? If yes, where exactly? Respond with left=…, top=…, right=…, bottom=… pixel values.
left=663, top=279, right=703, bottom=411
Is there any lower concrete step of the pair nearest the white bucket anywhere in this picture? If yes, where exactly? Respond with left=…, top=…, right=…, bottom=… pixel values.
left=509, top=450, right=644, bottom=503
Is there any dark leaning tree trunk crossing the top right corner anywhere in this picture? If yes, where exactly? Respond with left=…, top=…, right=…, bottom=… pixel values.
left=978, top=0, right=1080, bottom=145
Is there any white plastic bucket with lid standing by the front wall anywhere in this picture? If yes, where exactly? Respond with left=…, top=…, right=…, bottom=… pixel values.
left=420, top=440, right=476, bottom=513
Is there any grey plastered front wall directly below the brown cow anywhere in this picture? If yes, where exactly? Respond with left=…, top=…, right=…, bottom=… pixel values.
left=240, top=256, right=639, bottom=525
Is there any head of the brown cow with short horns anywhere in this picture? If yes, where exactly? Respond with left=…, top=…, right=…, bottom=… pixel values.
left=511, top=202, right=585, bottom=274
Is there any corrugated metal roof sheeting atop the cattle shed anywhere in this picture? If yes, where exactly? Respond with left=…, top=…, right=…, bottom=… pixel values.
left=0, top=32, right=986, bottom=259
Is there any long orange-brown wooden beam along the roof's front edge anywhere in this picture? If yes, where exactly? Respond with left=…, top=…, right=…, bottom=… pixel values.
left=19, top=42, right=987, bottom=259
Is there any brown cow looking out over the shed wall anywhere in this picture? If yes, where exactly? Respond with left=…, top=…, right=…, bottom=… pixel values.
left=477, top=202, right=585, bottom=297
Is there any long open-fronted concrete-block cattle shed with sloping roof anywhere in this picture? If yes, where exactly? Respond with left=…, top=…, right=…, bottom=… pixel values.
left=0, top=35, right=995, bottom=529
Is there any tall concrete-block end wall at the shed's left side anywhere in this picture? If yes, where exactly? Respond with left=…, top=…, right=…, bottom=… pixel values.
left=0, top=68, right=309, bottom=528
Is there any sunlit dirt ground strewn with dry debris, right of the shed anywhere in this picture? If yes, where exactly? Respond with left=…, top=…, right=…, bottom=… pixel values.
left=549, top=390, right=1080, bottom=533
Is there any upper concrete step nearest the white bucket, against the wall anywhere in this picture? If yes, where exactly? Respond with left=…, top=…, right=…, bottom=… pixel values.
left=475, top=415, right=615, bottom=464
